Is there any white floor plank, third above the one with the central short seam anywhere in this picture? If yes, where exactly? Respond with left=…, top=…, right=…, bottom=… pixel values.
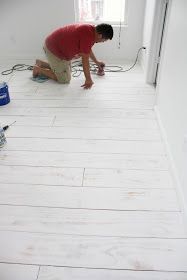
left=6, top=126, right=161, bottom=141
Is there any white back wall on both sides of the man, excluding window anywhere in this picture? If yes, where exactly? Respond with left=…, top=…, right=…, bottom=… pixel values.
left=0, top=0, right=145, bottom=62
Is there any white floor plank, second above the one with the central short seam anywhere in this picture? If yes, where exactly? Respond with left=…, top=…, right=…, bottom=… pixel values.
left=2, top=138, right=165, bottom=155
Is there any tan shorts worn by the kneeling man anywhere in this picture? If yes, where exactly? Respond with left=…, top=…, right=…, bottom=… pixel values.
left=43, top=46, right=71, bottom=84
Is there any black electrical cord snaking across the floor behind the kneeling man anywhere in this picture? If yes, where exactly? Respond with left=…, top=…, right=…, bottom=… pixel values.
left=1, top=47, right=146, bottom=77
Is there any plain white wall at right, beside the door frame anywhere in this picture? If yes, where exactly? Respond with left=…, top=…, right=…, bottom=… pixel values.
left=157, top=0, right=187, bottom=210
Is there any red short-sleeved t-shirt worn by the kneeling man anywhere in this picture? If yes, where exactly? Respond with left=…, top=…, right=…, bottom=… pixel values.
left=45, top=24, right=95, bottom=60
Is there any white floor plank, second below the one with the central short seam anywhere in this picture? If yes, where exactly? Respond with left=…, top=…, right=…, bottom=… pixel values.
left=0, top=205, right=184, bottom=238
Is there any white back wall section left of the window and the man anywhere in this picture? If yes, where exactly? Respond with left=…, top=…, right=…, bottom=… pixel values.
left=0, top=0, right=74, bottom=58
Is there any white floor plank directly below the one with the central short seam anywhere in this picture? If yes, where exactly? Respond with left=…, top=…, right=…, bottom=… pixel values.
left=0, top=184, right=180, bottom=211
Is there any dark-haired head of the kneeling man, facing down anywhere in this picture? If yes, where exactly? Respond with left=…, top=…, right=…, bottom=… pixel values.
left=95, top=23, right=114, bottom=43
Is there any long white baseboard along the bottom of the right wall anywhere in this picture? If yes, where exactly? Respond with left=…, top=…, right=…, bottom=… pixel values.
left=154, top=106, right=187, bottom=223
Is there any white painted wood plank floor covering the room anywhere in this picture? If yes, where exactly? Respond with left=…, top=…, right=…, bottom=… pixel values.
left=0, top=62, right=187, bottom=280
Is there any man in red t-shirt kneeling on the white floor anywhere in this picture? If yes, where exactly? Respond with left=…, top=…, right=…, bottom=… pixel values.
left=33, top=23, right=113, bottom=89
